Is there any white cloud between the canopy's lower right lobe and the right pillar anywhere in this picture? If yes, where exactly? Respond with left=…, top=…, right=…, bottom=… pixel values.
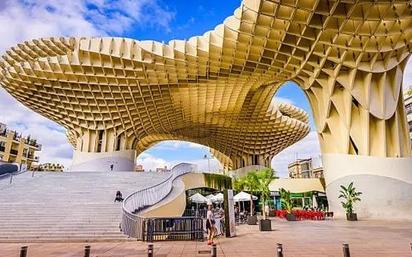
left=272, top=131, right=320, bottom=177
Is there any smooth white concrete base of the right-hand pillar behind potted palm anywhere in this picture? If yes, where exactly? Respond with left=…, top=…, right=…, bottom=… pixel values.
left=323, top=154, right=412, bottom=220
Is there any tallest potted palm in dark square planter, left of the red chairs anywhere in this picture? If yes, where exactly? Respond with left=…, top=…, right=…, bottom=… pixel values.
left=257, top=168, right=274, bottom=231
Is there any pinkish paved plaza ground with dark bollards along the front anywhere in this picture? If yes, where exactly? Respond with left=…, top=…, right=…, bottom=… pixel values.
left=0, top=219, right=412, bottom=257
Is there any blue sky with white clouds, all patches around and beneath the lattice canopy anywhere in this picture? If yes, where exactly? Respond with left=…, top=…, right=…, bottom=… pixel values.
left=0, top=0, right=412, bottom=176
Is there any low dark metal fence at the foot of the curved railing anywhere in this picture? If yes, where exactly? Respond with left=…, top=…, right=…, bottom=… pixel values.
left=145, top=217, right=204, bottom=242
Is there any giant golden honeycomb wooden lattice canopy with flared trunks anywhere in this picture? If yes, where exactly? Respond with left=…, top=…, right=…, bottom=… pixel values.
left=0, top=0, right=412, bottom=170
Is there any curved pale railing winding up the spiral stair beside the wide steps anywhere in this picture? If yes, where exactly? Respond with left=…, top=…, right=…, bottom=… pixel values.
left=121, top=163, right=196, bottom=240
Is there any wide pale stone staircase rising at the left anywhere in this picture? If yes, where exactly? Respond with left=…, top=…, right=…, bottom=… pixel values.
left=0, top=172, right=167, bottom=242
